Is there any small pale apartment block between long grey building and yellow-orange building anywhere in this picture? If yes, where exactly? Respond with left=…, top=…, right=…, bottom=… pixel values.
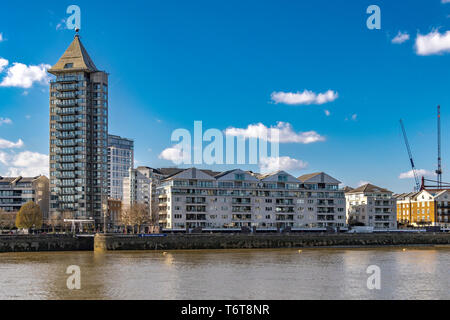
left=345, top=184, right=397, bottom=229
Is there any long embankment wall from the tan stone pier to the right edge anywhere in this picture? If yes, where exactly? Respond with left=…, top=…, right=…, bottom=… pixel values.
left=94, top=233, right=450, bottom=251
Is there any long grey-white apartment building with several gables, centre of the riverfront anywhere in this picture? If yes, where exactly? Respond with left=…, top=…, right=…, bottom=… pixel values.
left=158, top=168, right=345, bottom=230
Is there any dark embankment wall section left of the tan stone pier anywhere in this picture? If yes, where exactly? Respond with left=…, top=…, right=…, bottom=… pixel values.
left=0, top=235, right=94, bottom=252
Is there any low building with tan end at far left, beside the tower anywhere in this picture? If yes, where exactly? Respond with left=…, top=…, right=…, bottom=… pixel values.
left=0, top=176, right=49, bottom=222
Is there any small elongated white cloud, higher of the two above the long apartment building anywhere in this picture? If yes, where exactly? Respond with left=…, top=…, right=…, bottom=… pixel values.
left=271, top=90, right=338, bottom=105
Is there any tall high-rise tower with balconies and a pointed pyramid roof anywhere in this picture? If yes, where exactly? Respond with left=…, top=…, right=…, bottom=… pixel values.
left=48, top=34, right=108, bottom=227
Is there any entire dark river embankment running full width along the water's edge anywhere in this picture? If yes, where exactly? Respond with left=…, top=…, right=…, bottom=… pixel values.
left=0, top=233, right=450, bottom=253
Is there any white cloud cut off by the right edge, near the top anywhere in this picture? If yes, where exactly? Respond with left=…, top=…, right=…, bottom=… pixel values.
left=415, top=30, right=450, bottom=56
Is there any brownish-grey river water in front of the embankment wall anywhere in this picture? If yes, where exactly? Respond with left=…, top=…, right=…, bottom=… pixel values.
left=0, top=247, right=450, bottom=300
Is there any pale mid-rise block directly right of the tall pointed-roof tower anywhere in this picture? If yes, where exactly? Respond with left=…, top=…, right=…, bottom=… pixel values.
left=108, top=135, right=134, bottom=200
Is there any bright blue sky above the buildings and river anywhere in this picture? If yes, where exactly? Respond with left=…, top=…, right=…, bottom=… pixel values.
left=0, top=0, right=450, bottom=192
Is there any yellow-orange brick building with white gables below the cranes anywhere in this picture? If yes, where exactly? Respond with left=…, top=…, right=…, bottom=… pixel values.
left=395, top=190, right=450, bottom=227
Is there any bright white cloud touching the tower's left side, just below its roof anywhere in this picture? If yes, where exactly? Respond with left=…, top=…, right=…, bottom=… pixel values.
left=0, top=62, right=50, bottom=88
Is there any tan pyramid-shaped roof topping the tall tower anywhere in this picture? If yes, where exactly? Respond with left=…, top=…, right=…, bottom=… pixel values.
left=48, top=35, right=98, bottom=74
